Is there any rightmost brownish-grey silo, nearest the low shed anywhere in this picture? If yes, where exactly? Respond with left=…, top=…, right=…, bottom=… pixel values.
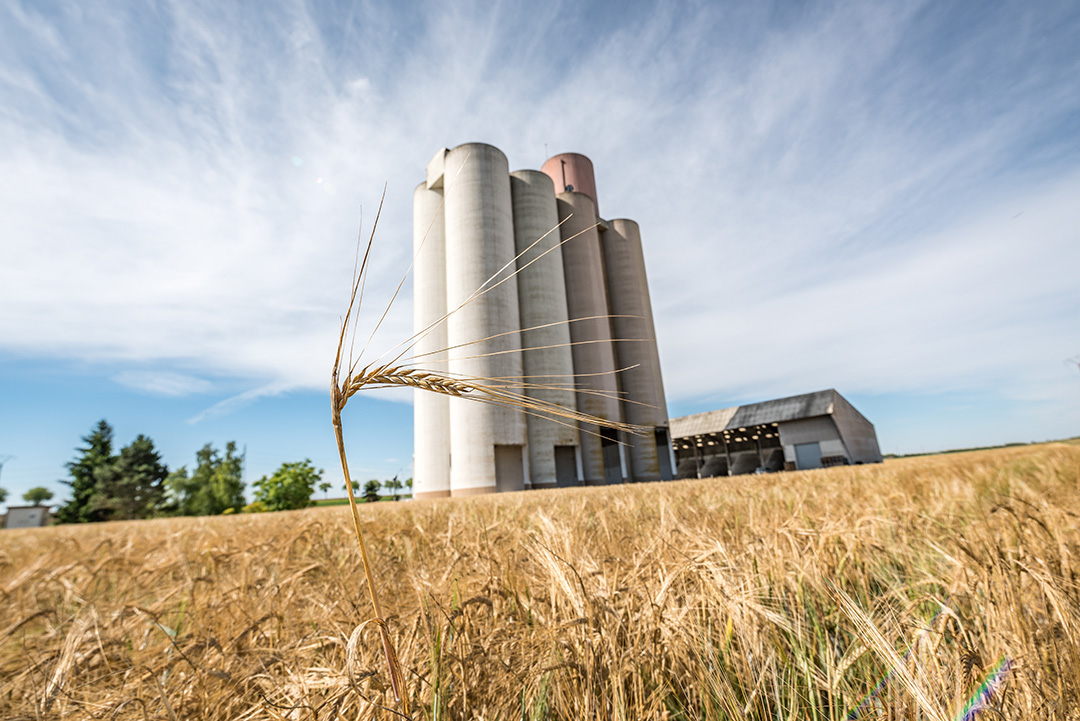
left=602, top=219, right=672, bottom=480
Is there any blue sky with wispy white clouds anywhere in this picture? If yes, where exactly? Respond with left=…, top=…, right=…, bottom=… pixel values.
left=0, top=0, right=1080, bottom=503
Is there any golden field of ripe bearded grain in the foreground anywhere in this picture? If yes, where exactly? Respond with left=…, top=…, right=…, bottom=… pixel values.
left=0, top=443, right=1080, bottom=720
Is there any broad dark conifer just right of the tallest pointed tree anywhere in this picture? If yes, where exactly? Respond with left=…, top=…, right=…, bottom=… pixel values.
left=89, top=434, right=168, bottom=520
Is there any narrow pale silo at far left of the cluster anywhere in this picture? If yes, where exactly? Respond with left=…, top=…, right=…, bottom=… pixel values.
left=413, top=182, right=450, bottom=499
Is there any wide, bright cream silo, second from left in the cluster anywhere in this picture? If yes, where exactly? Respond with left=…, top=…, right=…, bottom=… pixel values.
left=443, top=142, right=526, bottom=495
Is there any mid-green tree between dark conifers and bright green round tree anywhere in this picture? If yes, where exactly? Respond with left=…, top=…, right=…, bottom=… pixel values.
left=165, top=440, right=244, bottom=516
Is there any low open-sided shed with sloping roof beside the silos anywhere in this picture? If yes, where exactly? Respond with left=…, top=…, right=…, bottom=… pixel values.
left=671, top=389, right=881, bottom=478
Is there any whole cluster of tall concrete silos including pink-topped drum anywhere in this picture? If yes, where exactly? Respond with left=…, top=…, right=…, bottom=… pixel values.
left=413, top=142, right=673, bottom=499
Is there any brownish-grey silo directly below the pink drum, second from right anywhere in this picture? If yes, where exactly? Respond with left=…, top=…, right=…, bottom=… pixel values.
left=557, top=192, right=623, bottom=484
